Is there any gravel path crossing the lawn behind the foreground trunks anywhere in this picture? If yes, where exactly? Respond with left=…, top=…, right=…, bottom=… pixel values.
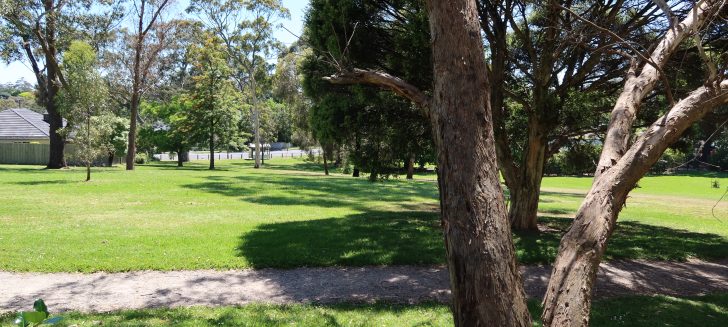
left=0, top=260, right=728, bottom=313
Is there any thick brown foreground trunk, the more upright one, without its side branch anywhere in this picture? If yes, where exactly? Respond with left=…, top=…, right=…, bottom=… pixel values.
left=427, top=0, right=531, bottom=326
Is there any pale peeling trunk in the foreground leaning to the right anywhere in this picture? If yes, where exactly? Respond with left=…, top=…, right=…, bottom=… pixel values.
left=542, top=81, right=728, bottom=326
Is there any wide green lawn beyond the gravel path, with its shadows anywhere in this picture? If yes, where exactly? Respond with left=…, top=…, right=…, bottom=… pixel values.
left=0, top=159, right=728, bottom=272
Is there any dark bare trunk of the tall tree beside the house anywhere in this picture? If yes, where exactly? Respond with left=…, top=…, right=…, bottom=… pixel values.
left=44, top=0, right=66, bottom=169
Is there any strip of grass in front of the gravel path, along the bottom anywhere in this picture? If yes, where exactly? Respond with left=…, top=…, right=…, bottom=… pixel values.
left=0, top=294, right=728, bottom=327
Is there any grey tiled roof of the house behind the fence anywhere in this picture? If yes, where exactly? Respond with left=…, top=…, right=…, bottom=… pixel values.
left=0, top=108, right=50, bottom=140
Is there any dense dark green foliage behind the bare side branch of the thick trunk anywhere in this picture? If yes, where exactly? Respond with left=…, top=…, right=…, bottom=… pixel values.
left=302, top=0, right=434, bottom=179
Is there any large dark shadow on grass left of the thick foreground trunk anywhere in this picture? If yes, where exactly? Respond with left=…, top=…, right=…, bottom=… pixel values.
left=237, top=211, right=445, bottom=268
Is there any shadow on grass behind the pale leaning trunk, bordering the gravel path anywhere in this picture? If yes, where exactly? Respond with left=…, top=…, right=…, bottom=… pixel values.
left=514, top=217, right=728, bottom=263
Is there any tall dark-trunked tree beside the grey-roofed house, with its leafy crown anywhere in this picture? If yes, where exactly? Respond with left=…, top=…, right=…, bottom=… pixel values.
left=0, top=0, right=121, bottom=169
